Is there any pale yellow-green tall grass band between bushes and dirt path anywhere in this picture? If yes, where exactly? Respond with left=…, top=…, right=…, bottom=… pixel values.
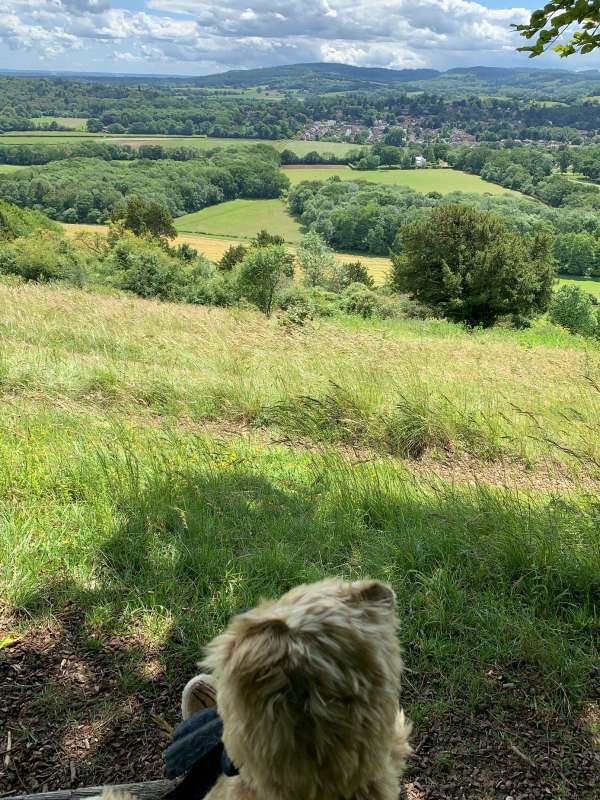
left=0, top=286, right=600, bottom=466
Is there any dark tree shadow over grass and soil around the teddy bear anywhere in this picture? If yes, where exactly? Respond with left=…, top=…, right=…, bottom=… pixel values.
left=5, top=455, right=595, bottom=798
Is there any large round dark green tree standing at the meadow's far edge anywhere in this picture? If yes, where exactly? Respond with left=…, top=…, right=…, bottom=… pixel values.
left=391, top=204, right=554, bottom=327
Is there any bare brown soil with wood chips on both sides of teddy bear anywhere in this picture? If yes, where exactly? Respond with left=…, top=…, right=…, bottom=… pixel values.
left=0, top=608, right=600, bottom=800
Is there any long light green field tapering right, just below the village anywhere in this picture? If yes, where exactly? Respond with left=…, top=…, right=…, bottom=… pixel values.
left=283, top=167, right=520, bottom=194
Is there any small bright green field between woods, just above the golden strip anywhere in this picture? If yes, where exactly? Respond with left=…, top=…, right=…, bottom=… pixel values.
left=175, top=200, right=302, bottom=242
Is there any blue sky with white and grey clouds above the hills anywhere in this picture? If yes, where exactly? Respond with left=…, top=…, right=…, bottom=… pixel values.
left=0, top=0, right=600, bottom=75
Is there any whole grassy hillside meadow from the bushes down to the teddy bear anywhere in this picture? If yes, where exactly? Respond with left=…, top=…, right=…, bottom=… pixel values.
left=0, top=284, right=600, bottom=800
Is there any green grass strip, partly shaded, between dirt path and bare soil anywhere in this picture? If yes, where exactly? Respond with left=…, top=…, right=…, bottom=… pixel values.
left=0, top=414, right=600, bottom=705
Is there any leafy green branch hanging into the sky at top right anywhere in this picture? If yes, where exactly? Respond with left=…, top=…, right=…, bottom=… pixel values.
left=513, top=0, right=600, bottom=58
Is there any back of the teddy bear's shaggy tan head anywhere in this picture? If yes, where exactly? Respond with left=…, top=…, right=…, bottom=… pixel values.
left=204, top=579, right=402, bottom=800
